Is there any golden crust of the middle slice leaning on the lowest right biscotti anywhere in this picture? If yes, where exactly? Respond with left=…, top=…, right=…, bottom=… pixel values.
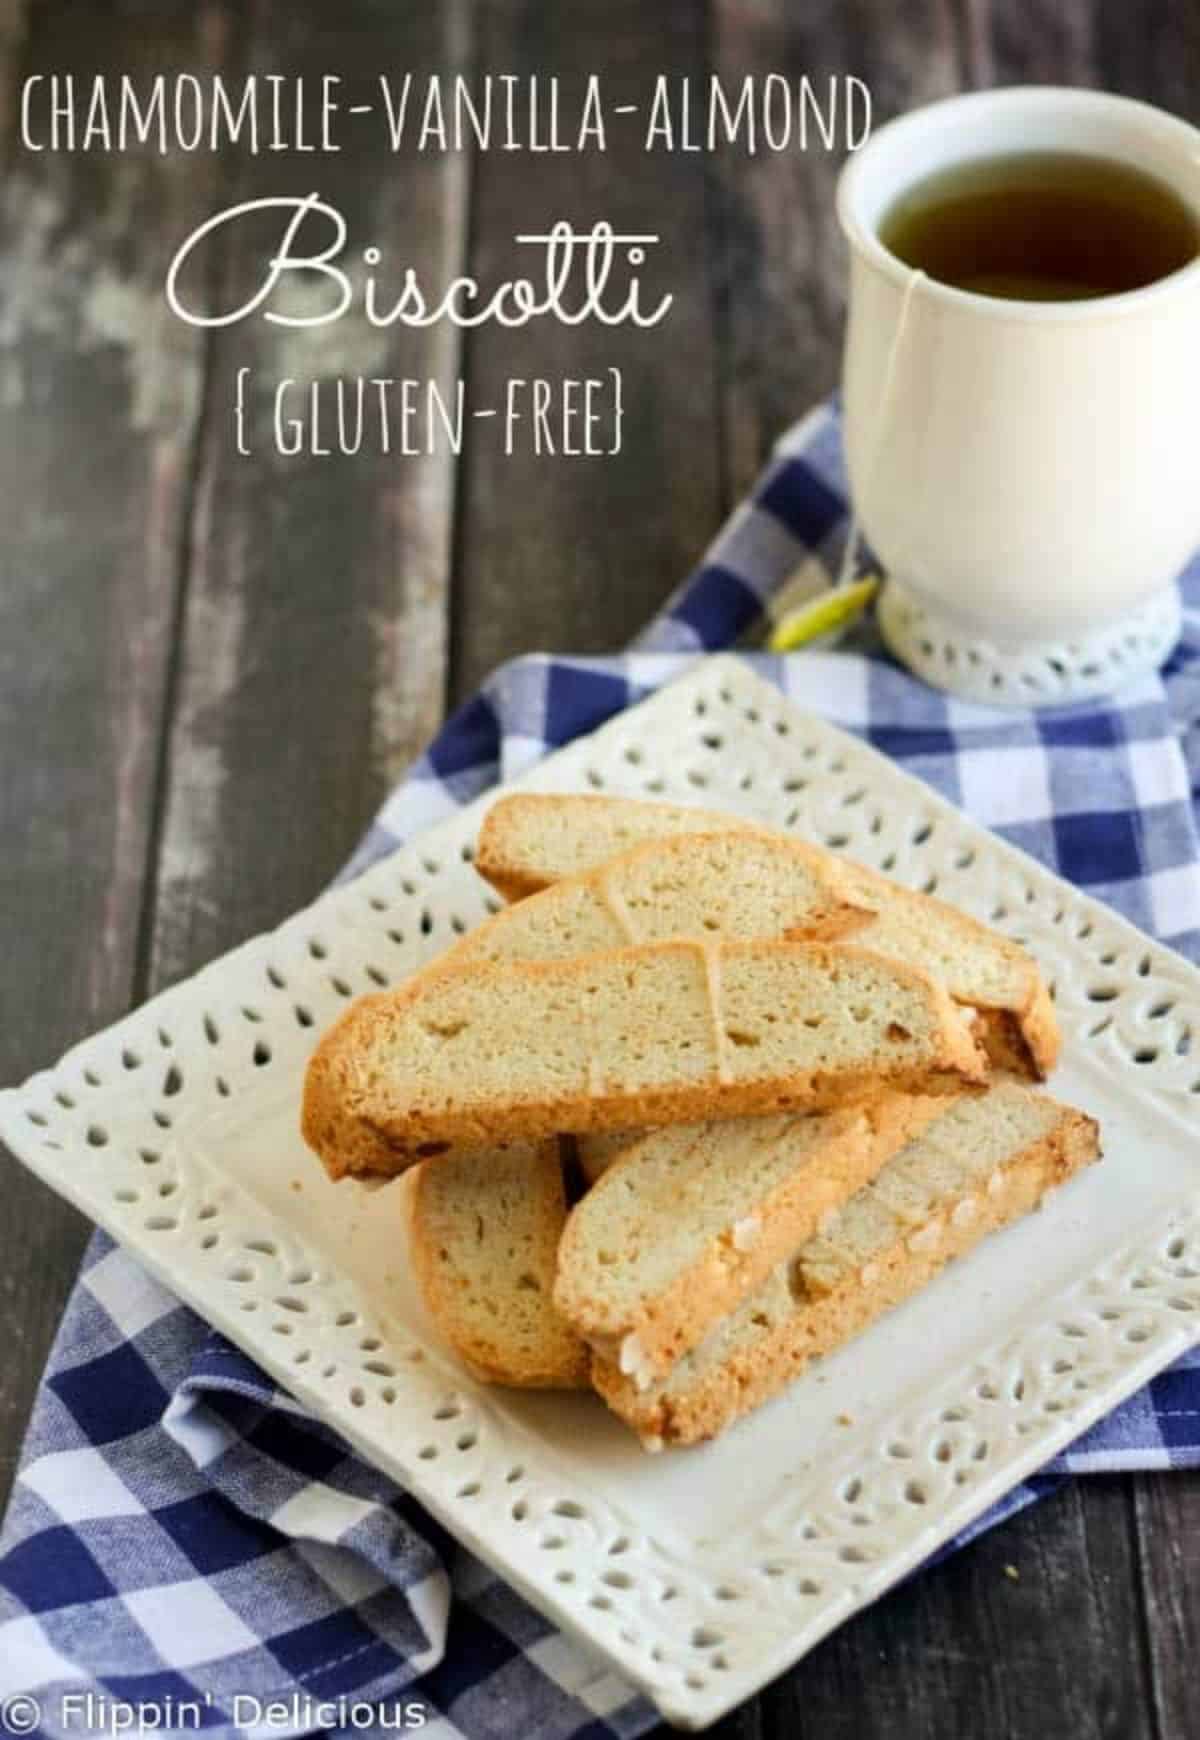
left=555, top=1094, right=948, bottom=1376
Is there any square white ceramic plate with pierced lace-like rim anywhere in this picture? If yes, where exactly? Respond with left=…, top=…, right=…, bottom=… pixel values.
left=0, top=658, right=1200, bottom=1728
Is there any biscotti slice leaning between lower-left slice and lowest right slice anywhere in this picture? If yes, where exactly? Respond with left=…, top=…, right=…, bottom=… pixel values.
left=555, top=1093, right=944, bottom=1387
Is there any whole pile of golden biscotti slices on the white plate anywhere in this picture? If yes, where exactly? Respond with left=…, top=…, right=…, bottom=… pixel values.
left=303, top=795, right=1097, bottom=1446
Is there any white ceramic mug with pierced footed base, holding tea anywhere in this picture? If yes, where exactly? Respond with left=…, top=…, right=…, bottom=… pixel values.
left=838, top=87, right=1200, bottom=699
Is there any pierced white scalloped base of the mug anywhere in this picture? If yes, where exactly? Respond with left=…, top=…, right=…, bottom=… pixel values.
left=878, top=579, right=1181, bottom=706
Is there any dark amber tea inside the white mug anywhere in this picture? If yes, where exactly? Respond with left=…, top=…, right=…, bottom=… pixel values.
left=878, top=151, right=1200, bottom=303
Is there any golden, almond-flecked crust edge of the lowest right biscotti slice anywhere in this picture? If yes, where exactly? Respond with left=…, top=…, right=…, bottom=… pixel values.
left=591, top=1107, right=1099, bottom=1444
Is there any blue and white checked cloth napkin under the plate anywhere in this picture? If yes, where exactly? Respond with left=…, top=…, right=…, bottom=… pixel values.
left=0, top=407, right=1200, bottom=1740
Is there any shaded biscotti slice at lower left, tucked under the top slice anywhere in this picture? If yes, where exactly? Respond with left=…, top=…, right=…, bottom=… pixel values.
left=410, top=1141, right=588, bottom=1390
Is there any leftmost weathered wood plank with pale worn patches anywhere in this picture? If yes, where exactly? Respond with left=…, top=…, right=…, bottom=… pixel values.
left=0, top=0, right=221, bottom=1495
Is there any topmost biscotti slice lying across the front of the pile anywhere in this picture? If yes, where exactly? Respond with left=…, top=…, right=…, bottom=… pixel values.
left=303, top=941, right=986, bottom=1176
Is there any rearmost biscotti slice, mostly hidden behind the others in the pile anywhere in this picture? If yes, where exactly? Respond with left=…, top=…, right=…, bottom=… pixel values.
left=475, top=792, right=753, bottom=900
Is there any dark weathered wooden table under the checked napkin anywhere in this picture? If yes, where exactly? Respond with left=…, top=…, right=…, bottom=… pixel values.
left=0, top=0, right=1200, bottom=1740
